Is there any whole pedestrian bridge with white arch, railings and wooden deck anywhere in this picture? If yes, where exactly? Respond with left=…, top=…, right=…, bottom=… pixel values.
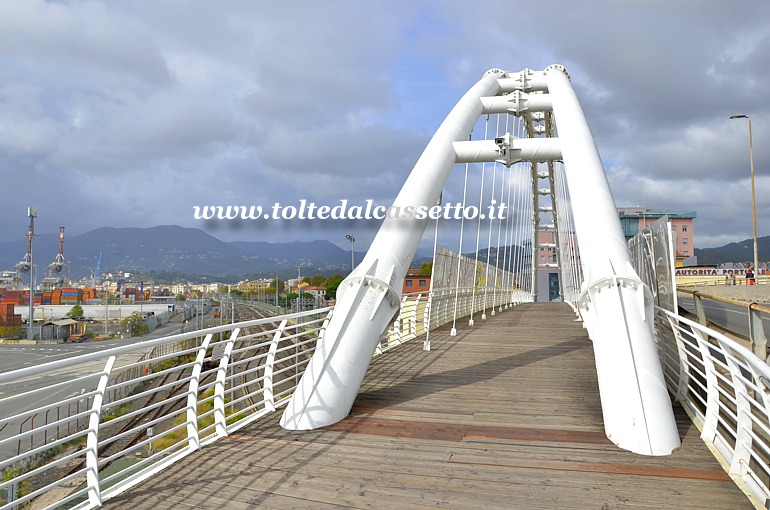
left=0, top=65, right=770, bottom=509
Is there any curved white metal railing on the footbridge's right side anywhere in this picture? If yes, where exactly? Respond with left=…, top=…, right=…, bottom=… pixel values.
left=655, top=307, right=770, bottom=508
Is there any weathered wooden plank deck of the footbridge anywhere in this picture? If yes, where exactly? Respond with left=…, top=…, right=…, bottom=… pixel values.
left=105, top=303, right=751, bottom=510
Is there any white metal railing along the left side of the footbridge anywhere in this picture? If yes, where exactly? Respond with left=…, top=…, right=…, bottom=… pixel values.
left=0, top=288, right=531, bottom=509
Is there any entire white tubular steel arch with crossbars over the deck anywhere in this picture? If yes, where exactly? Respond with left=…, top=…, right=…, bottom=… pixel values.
left=281, top=66, right=680, bottom=455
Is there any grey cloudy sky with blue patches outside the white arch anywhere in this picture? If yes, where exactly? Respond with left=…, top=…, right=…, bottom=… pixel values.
left=0, top=0, right=770, bottom=255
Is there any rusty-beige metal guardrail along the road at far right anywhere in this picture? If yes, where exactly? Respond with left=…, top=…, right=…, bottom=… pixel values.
left=677, top=287, right=770, bottom=361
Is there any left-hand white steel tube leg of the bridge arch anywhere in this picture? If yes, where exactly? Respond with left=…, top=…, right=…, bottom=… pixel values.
left=280, top=70, right=505, bottom=430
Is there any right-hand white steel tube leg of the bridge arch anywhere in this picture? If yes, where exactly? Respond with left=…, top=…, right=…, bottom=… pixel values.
left=545, top=66, right=681, bottom=455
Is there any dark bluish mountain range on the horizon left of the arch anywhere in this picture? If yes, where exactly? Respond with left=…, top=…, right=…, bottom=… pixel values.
left=0, top=225, right=363, bottom=280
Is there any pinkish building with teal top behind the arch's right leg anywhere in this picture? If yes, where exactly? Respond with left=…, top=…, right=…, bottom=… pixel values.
left=618, top=207, right=697, bottom=267
